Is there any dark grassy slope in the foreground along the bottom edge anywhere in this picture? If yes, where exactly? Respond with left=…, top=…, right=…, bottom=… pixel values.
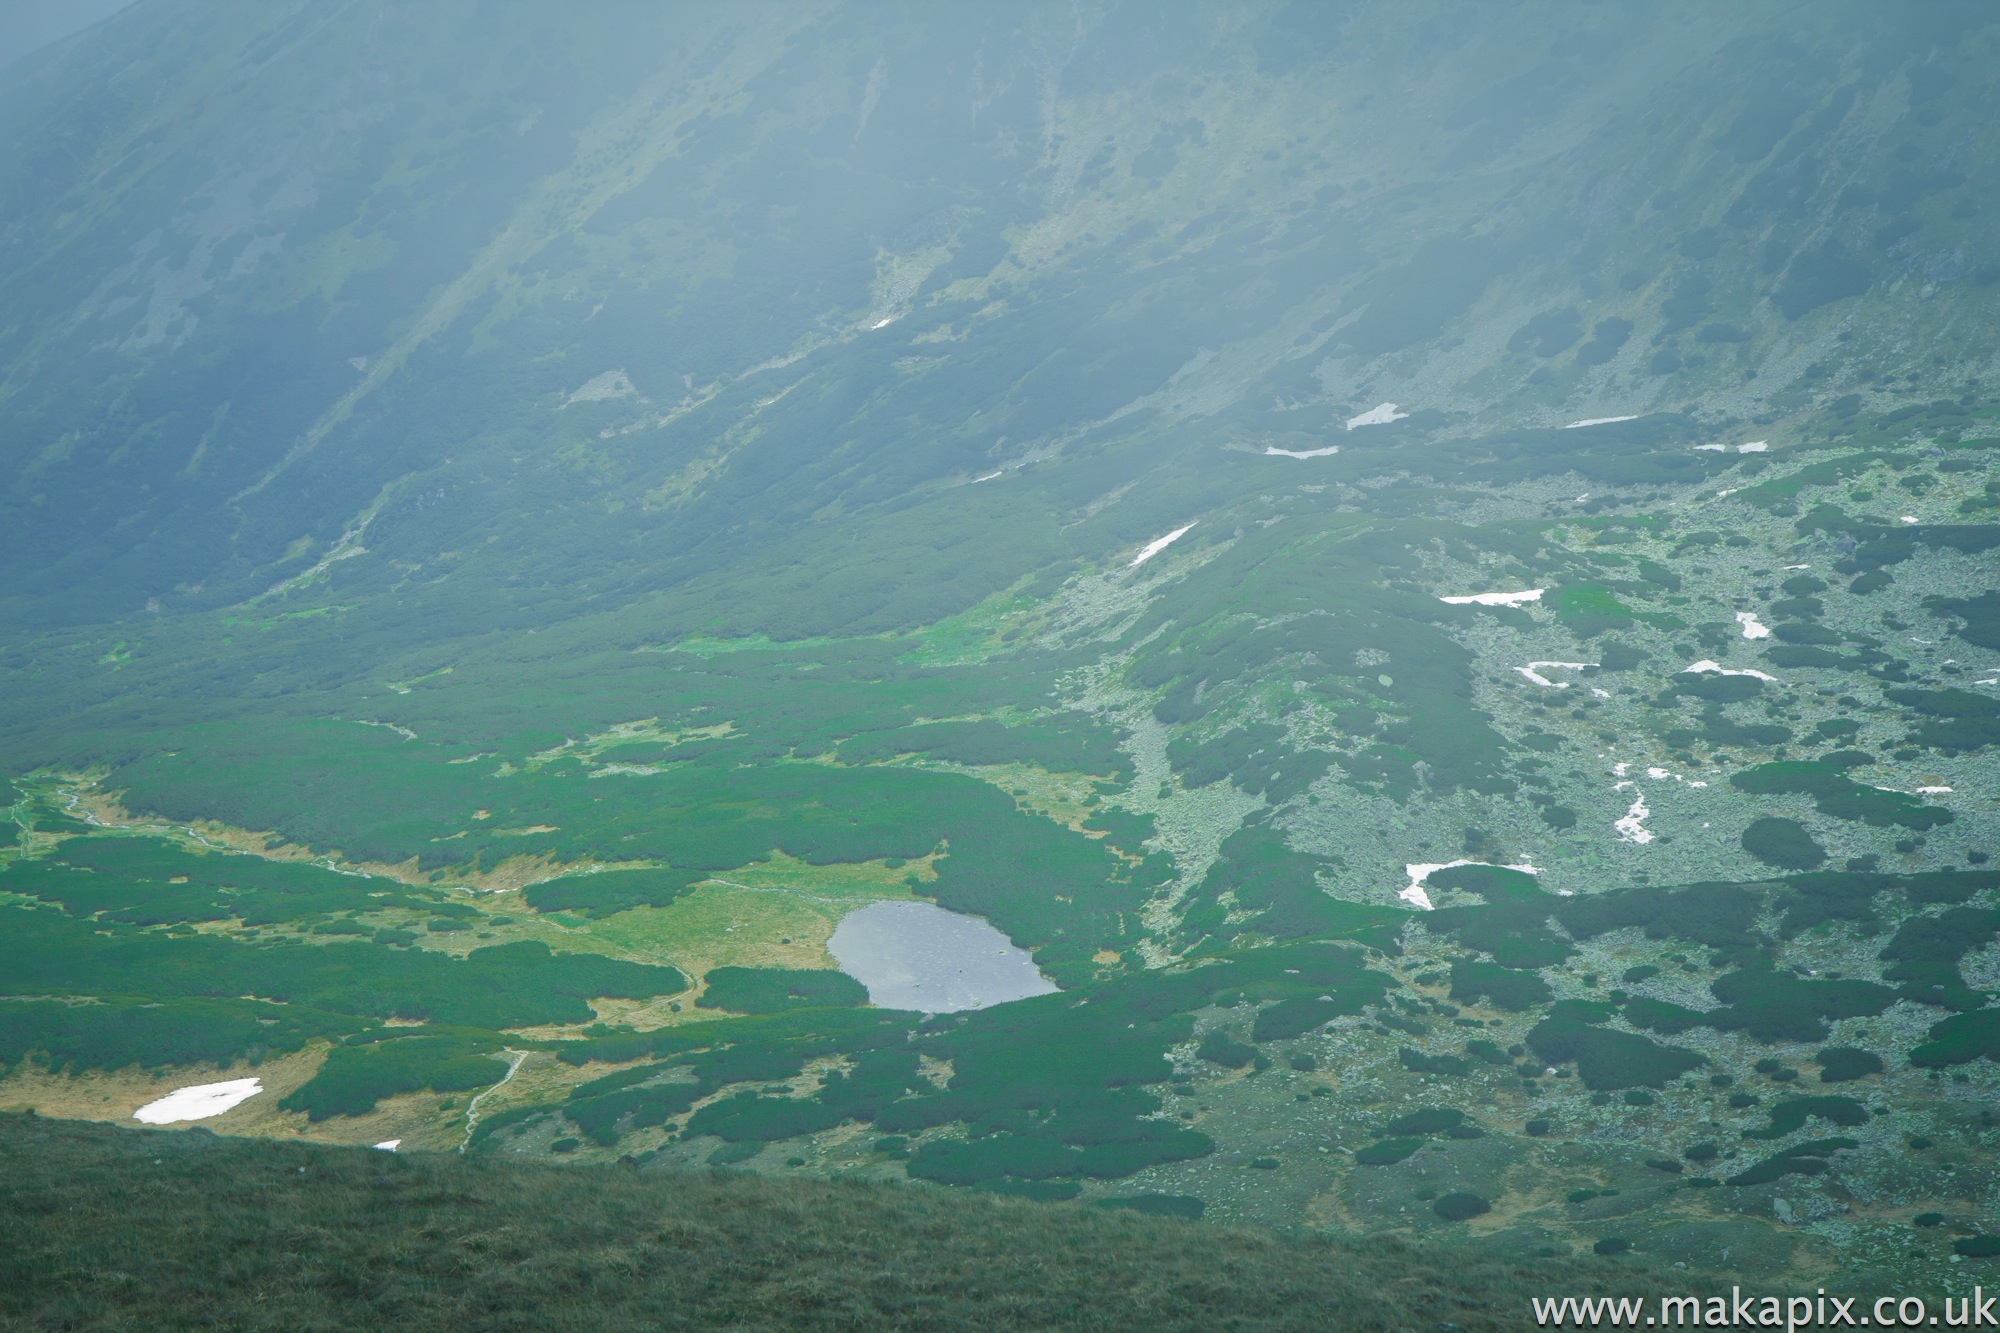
left=0, top=1115, right=1688, bottom=1331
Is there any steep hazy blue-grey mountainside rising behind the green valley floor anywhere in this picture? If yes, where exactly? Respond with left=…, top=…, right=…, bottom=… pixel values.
left=0, top=4, right=2000, bottom=636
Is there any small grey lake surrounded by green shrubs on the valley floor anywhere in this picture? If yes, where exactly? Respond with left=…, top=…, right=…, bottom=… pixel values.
left=826, top=903, right=1058, bottom=1013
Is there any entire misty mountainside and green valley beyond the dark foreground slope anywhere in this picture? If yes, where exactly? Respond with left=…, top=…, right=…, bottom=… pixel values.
left=0, top=0, right=2000, bottom=1289
